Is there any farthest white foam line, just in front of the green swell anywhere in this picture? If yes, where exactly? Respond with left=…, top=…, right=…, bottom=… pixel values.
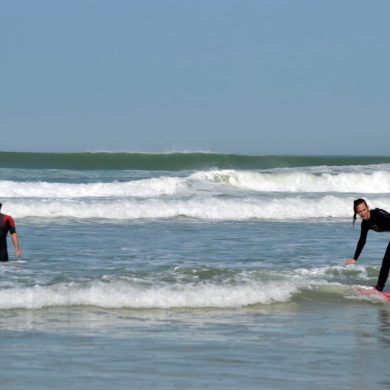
left=0, top=170, right=390, bottom=199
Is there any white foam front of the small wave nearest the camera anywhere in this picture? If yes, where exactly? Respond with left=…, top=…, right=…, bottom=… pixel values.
left=0, top=281, right=298, bottom=309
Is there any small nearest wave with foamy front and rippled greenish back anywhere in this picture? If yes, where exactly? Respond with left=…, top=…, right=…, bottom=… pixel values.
left=0, top=265, right=378, bottom=310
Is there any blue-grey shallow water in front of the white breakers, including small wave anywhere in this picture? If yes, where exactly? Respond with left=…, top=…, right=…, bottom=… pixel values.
left=0, top=221, right=390, bottom=389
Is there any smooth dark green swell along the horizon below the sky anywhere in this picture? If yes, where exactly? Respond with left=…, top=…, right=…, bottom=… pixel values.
left=0, top=152, right=390, bottom=171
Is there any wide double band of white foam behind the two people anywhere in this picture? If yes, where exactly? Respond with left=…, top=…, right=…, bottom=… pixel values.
left=0, top=166, right=390, bottom=220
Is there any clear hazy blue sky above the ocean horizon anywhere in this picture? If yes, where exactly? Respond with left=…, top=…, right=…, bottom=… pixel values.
left=0, top=0, right=390, bottom=155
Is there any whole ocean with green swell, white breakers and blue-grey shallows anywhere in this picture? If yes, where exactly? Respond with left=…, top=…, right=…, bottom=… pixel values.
left=0, top=152, right=390, bottom=389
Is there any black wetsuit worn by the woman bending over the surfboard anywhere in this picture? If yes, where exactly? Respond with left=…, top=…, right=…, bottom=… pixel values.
left=353, top=209, right=390, bottom=291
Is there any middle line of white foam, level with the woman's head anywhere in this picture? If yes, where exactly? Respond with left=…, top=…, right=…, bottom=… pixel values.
left=3, top=195, right=390, bottom=220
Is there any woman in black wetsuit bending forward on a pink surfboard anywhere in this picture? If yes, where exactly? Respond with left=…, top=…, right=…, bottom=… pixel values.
left=345, top=199, right=390, bottom=291
